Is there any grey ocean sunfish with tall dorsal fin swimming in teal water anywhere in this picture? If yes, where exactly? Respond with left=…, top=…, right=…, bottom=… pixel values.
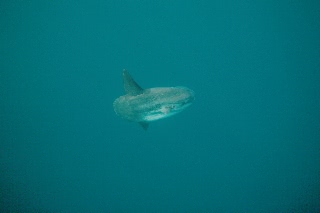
left=113, top=69, right=195, bottom=130
